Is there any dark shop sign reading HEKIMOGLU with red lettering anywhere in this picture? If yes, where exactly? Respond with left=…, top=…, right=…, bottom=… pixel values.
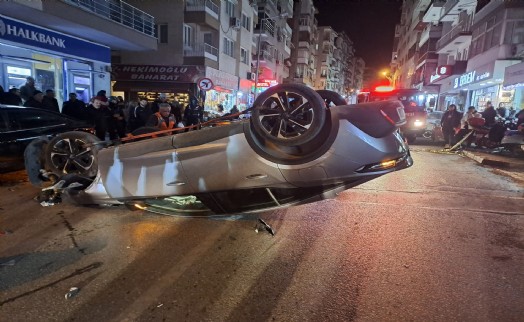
left=111, top=64, right=205, bottom=83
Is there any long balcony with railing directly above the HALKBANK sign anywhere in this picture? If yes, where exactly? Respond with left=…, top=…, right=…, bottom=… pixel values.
left=2, top=0, right=158, bottom=51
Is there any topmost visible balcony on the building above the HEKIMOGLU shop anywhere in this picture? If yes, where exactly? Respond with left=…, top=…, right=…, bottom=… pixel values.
left=184, top=0, right=220, bottom=30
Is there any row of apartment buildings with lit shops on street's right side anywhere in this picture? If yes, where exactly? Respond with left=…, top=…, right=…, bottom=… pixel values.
left=392, top=0, right=524, bottom=111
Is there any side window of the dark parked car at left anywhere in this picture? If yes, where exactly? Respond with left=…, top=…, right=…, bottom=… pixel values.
left=9, top=108, right=67, bottom=130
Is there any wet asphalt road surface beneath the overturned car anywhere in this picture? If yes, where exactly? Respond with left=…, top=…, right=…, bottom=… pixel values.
left=0, top=146, right=524, bottom=321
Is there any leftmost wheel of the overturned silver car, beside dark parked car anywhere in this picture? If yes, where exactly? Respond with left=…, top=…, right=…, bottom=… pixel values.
left=45, top=131, right=101, bottom=177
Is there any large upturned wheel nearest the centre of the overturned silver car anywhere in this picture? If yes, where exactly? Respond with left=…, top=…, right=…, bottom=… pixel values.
left=251, top=84, right=326, bottom=146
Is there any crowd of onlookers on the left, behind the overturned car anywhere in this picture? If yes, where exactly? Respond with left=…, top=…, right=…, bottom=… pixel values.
left=0, top=77, right=244, bottom=140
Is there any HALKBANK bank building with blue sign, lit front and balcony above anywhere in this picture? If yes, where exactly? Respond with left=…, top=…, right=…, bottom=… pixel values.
left=0, top=0, right=157, bottom=106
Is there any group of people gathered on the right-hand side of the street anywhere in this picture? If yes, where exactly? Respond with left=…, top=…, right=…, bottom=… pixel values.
left=441, top=101, right=524, bottom=148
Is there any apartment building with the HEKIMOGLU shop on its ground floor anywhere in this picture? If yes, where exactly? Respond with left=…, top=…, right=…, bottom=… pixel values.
left=116, top=0, right=256, bottom=111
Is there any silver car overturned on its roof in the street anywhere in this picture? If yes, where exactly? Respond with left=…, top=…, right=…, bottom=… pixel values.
left=26, top=84, right=413, bottom=214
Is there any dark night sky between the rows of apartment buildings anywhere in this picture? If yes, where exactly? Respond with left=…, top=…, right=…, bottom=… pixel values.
left=313, top=0, right=402, bottom=70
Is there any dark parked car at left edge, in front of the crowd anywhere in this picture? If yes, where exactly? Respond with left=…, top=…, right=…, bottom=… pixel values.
left=0, top=105, right=92, bottom=173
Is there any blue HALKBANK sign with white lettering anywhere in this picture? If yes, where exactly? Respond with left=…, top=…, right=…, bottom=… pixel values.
left=0, top=15, right=111, bottom=63
